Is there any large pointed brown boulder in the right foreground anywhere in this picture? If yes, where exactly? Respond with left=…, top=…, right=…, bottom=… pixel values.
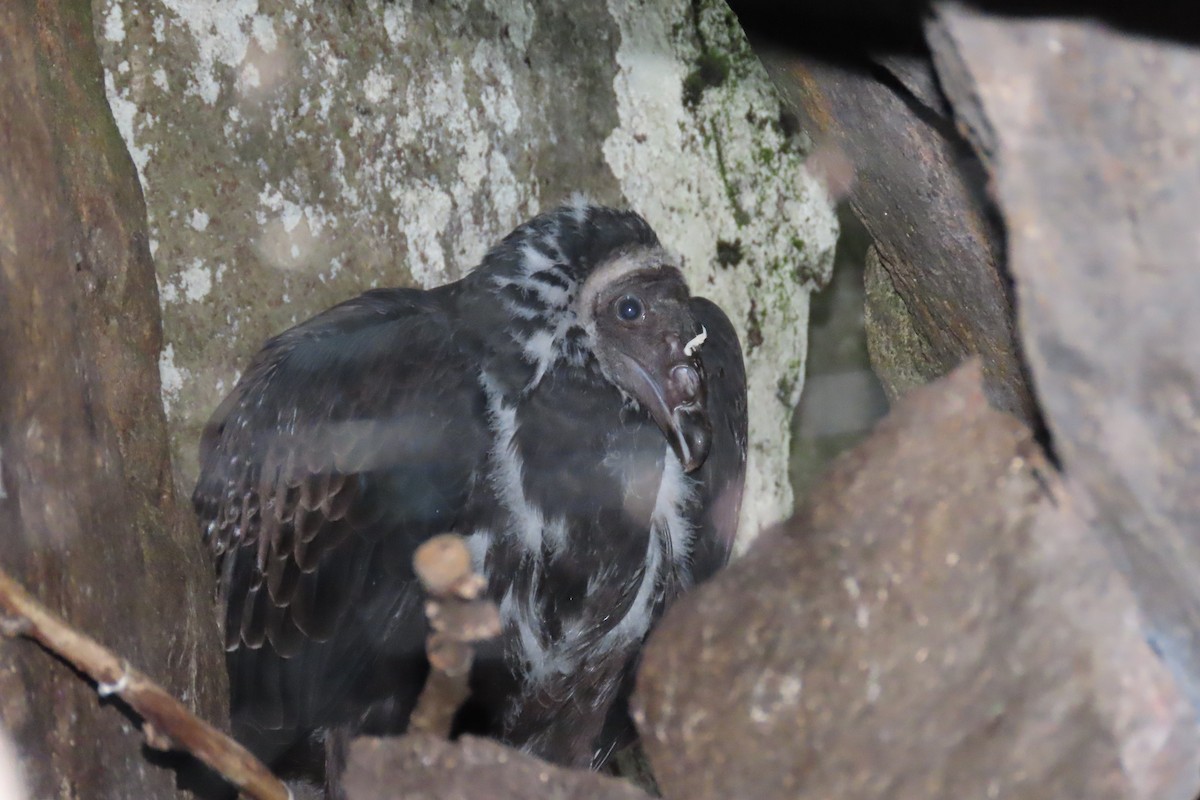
left=636, top=367, right=1200, bottom=800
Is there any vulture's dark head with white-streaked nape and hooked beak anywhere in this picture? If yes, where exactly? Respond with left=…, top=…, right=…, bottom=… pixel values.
left=484, top=204, right=712, bottom=471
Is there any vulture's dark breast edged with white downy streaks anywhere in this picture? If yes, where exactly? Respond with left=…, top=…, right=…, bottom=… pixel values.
left=476, top=369, right=692, bottom=682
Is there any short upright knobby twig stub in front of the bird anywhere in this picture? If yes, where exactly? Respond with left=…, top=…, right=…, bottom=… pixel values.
left=408, top=534, right=500, bottom=738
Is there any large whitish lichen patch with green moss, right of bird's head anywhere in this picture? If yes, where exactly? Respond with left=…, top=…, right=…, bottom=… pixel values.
left=604, top=0, right=838, bottom=547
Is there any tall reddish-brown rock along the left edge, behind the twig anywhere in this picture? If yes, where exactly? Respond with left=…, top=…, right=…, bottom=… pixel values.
left=0, top=2, right=226, bottom=798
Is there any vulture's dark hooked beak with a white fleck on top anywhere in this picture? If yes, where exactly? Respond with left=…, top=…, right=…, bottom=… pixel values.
left=629, top=356, right=713, bottom=473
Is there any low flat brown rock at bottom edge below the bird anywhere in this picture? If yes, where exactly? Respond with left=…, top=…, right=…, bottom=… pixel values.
left=346, top=734, right=650, bottom=800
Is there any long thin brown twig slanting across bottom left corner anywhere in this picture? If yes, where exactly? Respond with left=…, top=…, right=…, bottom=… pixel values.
left=0, top=570, right=292, bottom=800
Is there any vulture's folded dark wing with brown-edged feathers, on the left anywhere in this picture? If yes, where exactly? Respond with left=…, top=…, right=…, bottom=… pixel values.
left=193, top=290, right=487, bottom=728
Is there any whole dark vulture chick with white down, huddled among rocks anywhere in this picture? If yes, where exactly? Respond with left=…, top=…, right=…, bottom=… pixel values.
left=193, top=205, right=746, bottom=782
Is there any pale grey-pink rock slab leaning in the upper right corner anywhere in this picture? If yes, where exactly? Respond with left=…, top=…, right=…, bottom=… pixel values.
left=930, top=6, right=1200, bottom=706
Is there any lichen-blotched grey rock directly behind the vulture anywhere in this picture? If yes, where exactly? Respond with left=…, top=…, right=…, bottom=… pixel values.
left=96, top=0, right=836, bottom=546
